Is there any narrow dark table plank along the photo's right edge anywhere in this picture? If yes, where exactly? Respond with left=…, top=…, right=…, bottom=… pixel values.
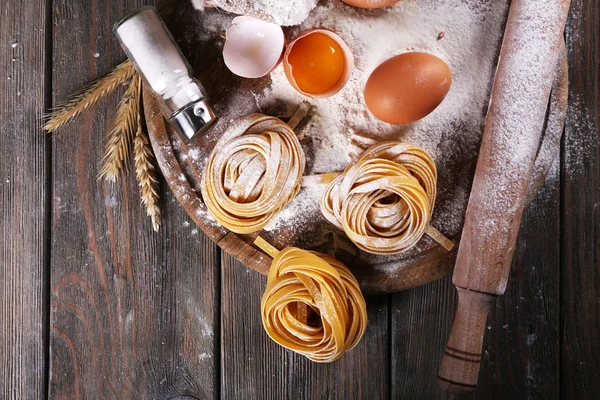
left=561, top=0, right=600, bottom=399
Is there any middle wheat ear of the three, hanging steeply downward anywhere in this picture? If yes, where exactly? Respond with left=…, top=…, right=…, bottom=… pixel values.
left=100, top=74, right=141, bottom=182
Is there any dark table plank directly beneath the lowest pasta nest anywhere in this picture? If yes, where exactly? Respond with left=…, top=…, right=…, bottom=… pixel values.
left=221, top=255, right=389, bottom=399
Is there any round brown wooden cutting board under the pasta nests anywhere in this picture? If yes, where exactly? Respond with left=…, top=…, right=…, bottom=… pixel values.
left=143, top=5, right=568, bottom=293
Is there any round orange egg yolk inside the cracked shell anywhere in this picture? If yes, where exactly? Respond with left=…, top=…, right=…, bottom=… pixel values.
left=288, top=33, right=345, bottom=93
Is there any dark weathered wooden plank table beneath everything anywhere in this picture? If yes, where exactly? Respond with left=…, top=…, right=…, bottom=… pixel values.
left=0, top=0, right=600, bottom=399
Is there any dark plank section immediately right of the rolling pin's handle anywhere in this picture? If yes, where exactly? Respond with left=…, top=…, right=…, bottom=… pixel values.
left=475, top=164, right=560, bottom=399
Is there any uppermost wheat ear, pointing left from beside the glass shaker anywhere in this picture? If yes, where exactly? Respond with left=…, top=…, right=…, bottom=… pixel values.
left=44, top=60, right=135, bottom=132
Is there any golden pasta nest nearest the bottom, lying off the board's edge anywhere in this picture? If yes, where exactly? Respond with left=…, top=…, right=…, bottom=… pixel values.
left=261, top=247, right=367, bottom=362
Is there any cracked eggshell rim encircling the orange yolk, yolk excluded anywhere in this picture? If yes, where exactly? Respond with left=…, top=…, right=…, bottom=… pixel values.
left=283, top=29, right=354, bottom=98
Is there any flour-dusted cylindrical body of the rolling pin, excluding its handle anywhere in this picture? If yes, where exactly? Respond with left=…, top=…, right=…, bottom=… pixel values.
left=454, top=1, right=565, bottom=294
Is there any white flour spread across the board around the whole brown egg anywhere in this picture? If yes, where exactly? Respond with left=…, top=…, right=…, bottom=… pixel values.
left=188, top=0, right=509, bottom=260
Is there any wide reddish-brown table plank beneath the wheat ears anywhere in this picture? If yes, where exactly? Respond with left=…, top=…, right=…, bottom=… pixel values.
left=49, top=0, right=219, bottom=398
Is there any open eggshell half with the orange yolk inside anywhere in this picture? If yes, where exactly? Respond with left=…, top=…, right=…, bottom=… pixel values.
left=283, top=29, right=354, bottom=98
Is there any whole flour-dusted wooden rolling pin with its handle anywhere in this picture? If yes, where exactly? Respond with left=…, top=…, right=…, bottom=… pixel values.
left=438, top=0, right=570, bottom=394
